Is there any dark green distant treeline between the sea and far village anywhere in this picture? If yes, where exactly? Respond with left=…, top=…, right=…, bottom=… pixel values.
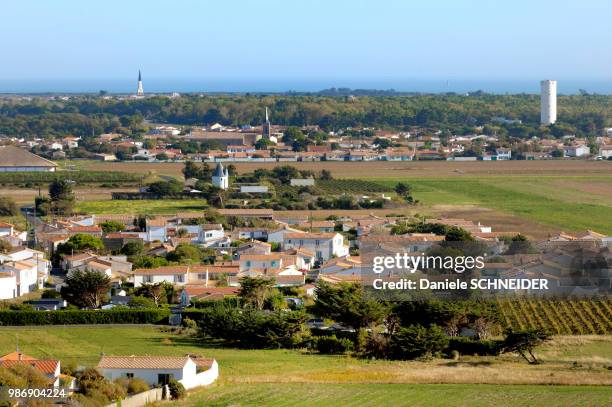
left=0, top=92, right=612, bottom=138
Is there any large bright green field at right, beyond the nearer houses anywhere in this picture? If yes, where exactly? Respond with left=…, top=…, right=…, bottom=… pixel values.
left=381, top=176, right=612, bottom=233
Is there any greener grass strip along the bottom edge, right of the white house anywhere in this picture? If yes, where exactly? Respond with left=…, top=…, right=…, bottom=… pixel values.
left=176, top=383, right=612, bottom=407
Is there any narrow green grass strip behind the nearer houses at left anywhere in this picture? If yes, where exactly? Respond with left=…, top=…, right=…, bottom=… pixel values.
left=77, top=199, right=206, bottom=215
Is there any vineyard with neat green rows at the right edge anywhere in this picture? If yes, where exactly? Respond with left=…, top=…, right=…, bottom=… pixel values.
left=498, top=299, right=612, bottom=335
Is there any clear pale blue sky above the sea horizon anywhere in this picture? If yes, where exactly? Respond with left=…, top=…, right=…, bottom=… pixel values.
left=0, top=0, right=612, bottom=81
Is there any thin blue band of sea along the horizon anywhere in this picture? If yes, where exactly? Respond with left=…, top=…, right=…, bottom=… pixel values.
left=0, top=76, right=612, bottom=94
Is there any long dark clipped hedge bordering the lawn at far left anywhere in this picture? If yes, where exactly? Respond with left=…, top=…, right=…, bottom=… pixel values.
left=0, top=308, right=170, bottom=326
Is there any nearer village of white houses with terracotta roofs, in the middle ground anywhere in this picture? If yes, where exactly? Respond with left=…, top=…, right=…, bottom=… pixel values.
left=0, top=204, right=612, bottom=302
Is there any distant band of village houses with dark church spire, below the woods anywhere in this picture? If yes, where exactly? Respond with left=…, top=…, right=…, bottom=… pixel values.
left=0, top=110, right=612, bottom=170
